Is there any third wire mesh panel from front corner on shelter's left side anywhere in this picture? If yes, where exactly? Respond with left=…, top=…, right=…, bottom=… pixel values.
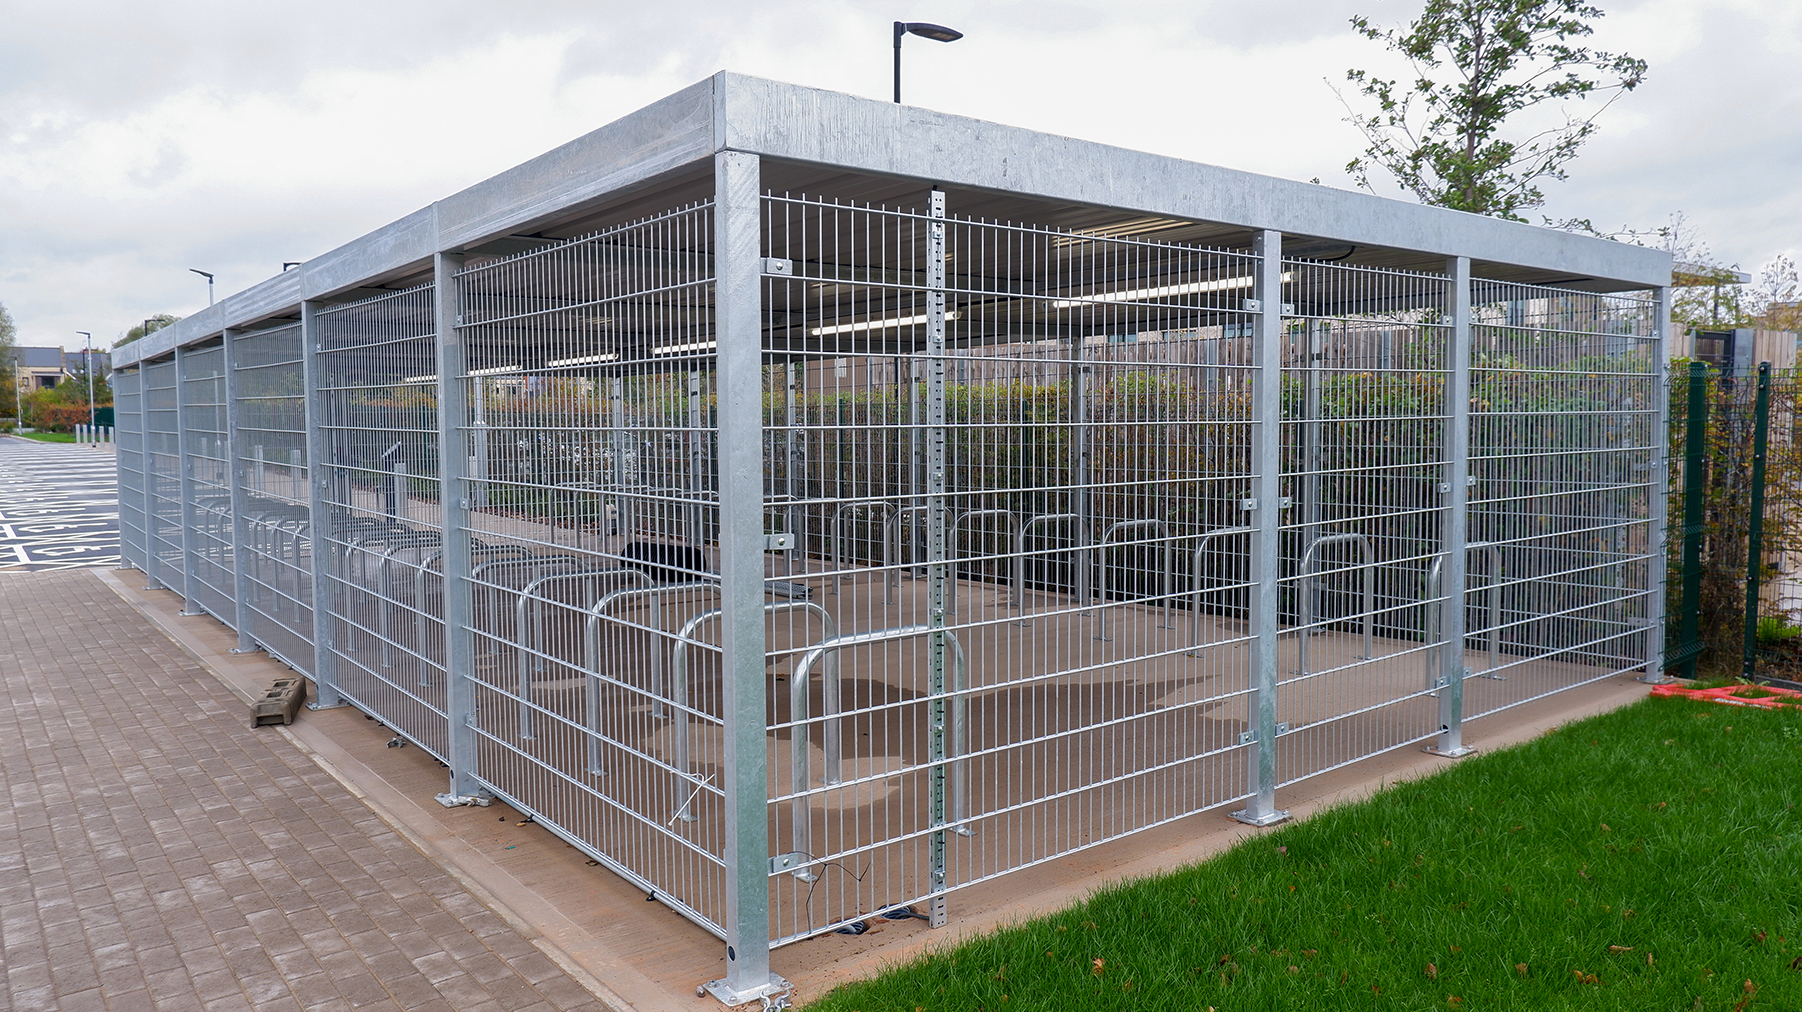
left=231, top=324, right=314, bottom=672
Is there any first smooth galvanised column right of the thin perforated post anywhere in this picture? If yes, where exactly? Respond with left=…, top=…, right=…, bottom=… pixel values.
left=1233, top=229, right=1288, bottom=827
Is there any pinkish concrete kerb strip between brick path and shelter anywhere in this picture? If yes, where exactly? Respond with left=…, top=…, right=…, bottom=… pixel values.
left=96, top=569, right=661, bottom=1012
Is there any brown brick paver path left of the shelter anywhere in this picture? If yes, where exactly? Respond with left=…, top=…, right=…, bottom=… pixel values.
left=0, top=571, right=604, bottom=1012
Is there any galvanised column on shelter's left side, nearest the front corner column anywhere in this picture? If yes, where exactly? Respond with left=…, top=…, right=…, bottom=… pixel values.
left=432, top=254, right=492, bottom=809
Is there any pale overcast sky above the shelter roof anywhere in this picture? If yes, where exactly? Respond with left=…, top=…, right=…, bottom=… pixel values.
left=0, top=0, right=1802, bottom=348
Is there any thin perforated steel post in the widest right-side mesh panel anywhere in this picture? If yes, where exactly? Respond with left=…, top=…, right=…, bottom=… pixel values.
left=926, top=189, right=955, bottom=927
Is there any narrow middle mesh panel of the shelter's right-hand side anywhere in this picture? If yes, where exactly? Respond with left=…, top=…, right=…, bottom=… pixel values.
left=1276, top=259, right=1452, bottom=783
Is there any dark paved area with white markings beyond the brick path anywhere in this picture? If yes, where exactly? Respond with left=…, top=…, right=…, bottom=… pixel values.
left=0, top=436, right=119, bottom=573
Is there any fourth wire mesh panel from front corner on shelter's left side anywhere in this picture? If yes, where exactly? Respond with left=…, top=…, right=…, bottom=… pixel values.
left=180, top=344, right=238, bottom=628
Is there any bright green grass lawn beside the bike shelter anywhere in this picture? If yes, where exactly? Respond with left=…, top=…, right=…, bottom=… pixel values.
left=807, top=699, right=1802, bottom=1012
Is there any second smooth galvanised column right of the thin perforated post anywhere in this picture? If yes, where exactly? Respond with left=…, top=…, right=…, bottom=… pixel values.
left=1425, top=256, right=1476, bottom=758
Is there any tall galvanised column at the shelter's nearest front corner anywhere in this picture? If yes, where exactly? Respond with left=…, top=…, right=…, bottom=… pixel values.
left=705, top=151, right=785, bottom=1005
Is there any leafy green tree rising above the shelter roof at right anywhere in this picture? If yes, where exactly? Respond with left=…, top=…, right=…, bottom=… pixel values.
left=1341, top=0, right=1645, bottom=221
